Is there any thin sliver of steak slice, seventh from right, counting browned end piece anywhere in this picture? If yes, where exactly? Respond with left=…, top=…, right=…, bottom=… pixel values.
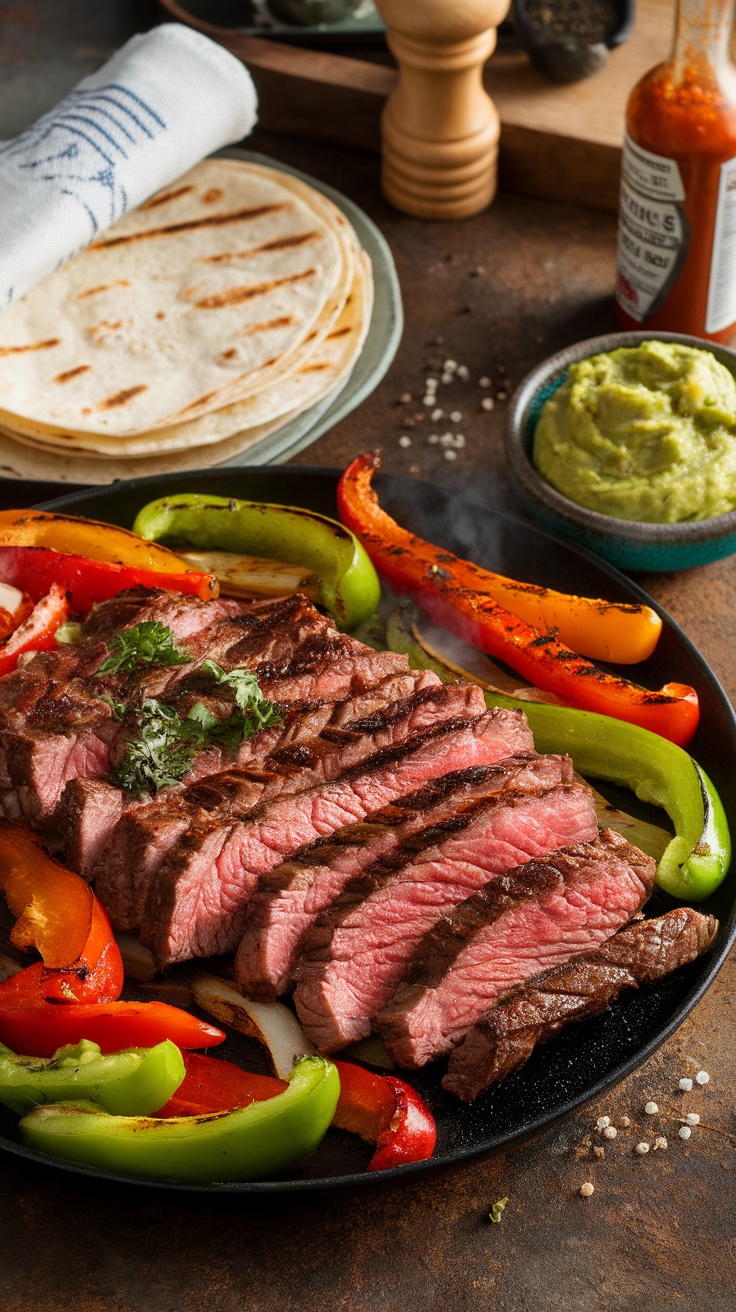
left=62, top=669, right=440, bottom=879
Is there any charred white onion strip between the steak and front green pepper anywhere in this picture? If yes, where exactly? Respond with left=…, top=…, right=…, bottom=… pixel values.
left=192, top=971, right=316, bottom=1080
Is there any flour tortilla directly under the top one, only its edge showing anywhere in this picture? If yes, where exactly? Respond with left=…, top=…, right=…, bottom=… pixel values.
left=0, top=252, right=373, bottom=458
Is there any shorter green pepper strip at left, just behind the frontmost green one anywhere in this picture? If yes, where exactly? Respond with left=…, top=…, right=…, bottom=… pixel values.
left=0, top=1039, right=186, bottom=1117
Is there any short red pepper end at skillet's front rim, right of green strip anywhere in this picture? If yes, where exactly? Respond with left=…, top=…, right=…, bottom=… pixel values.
left=332, top=1061, right=437, bottom=1170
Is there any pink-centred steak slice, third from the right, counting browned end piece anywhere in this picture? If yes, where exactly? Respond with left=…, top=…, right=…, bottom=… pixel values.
left=294, top=757, right=597, bottom=1052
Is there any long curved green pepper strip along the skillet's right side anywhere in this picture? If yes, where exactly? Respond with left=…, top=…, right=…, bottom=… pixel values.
left=386, top=611, right=731, bottom=901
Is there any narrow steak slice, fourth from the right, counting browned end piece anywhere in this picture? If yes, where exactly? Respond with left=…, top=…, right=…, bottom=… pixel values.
left=235, top=756, right=572, bottom=1000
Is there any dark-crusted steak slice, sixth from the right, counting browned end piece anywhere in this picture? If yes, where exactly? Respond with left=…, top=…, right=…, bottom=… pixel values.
left=94, top=682, right=484, bottom=928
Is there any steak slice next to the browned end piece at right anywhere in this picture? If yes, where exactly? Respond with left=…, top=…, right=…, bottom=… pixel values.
left=377, top=829, right=656, bottom=1067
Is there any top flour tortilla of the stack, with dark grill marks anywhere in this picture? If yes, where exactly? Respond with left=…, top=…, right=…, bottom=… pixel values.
left=0, top=160, right=354, bottom=436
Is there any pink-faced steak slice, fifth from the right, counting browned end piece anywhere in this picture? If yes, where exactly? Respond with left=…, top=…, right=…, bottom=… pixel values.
left=140, top=708, right=533, bottom=967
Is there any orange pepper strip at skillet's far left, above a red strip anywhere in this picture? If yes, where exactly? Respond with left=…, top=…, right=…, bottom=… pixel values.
left=0, top=510, right=219, bottom=600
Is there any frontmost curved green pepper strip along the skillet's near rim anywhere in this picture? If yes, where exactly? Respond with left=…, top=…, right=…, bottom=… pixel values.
left=20, top=1056, right=340, bottom=1183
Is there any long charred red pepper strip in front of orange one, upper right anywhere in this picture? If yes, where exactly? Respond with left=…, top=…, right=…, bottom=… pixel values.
left=337, top=454, right=699, bottom=747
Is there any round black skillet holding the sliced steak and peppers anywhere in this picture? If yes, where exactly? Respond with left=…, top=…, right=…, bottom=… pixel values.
left=0, top=466, right=736, bottom=1195
